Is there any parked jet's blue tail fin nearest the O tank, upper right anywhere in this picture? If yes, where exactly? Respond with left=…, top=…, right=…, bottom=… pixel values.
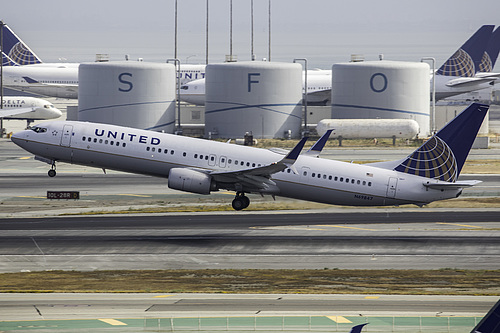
left=436, top=25, right=495, bottom=77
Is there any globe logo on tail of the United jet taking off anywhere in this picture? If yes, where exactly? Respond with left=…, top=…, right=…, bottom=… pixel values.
left=395, top=135, right=458, bottom=182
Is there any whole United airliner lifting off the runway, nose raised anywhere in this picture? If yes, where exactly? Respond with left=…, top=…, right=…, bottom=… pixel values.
left=12, top=104, right=489, bottom=210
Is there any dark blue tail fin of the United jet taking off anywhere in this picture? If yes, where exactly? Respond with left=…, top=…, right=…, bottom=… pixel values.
left=394, top=103, right=489, bottom=182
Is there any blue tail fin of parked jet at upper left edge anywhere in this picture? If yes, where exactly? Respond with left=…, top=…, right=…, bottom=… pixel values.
left=2, top=24, right=42, bottom=66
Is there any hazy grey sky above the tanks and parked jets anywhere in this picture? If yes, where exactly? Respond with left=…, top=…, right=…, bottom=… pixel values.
left=0, top=0, right=500, bottom=69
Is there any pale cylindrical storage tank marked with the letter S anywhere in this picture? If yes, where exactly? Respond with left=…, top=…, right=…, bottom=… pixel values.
left=78, top=61, right=176, bottom=133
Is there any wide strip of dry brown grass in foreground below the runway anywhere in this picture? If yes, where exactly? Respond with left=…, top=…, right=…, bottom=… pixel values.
left=0, top=268, right=500, bottom=296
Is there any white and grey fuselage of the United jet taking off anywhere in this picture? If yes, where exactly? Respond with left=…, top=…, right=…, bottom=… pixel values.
left=12, top=121, right=461, bottom=206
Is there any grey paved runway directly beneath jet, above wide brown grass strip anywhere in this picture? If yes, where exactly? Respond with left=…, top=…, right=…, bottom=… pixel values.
left=0, top=209, right=500, bottom=272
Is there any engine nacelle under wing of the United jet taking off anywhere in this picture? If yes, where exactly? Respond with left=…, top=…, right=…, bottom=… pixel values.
left=168, top=168, right=217, bottom=194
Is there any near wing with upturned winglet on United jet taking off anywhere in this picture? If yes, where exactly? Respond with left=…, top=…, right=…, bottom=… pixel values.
left=209, top=137, right=307, bottom=193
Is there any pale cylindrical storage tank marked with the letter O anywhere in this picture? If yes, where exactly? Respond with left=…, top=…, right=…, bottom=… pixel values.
left=332, top=60, right=430, bottom=137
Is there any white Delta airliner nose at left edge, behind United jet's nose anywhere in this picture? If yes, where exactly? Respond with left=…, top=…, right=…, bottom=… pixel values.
left=0, top=96, right=62, bottom=125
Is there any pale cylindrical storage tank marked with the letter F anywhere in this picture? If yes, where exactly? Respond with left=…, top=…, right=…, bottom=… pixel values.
left=205, top=61, right=302, bottom=138
